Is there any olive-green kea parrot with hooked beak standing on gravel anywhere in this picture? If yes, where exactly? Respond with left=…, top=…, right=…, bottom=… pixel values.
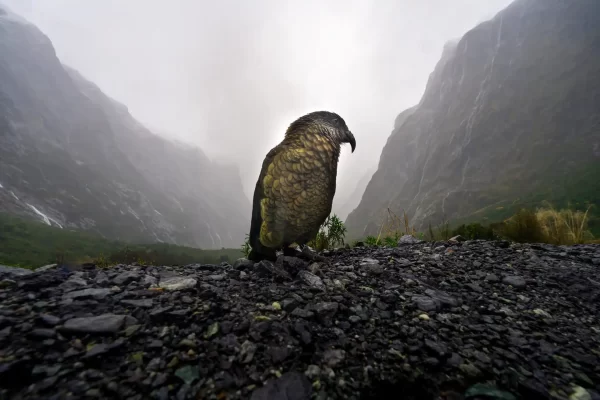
left=248, top=111, right=356, bottom=262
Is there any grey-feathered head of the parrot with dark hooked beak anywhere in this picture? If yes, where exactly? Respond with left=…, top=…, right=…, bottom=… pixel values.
left=288, top=111, right=356, bottom=153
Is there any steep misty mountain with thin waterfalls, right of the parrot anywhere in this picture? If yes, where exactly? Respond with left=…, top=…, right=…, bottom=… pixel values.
left=346, top=0, right=600, bottom=237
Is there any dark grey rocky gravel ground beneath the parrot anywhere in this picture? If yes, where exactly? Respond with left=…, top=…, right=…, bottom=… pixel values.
left=0, top=241, right=600, bottom=400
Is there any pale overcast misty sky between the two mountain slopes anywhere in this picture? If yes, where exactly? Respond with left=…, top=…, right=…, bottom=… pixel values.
left=0, top=0, right=511, bottom=205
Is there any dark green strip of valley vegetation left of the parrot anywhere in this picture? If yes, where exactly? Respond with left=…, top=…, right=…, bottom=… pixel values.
left=0, top=213, right=243, bottom=268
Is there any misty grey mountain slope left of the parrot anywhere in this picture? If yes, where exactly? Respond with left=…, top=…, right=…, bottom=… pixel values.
left=0, top=6, right=250, bottom=248
